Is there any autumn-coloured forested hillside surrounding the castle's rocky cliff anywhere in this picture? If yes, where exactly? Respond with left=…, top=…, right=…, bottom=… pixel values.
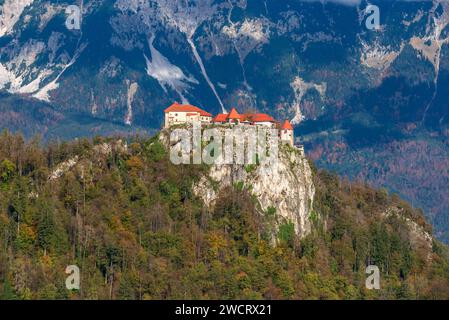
left=0, top=132, right=449, bottom=299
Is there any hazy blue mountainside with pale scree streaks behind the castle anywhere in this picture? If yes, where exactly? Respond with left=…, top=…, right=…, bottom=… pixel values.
left=0, top=0, right=449, bottom=240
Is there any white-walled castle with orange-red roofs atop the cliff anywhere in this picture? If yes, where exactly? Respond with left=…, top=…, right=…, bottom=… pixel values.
left=164, top=102, right=294, bottom=146
